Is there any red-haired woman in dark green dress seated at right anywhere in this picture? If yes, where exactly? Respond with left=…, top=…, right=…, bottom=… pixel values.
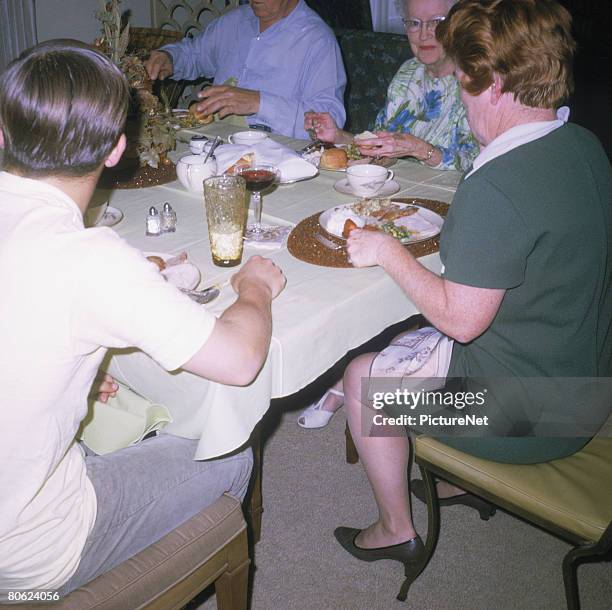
left=326, top=0, right=612, bottom=574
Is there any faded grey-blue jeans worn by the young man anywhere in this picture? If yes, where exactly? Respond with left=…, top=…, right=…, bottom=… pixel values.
left=58, top=434, right=253, bottom=596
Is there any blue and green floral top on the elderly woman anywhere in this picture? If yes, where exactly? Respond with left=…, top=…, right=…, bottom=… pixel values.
left=374, top=58, right=479, bottom=171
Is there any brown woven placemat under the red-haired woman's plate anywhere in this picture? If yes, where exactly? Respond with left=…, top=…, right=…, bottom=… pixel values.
left=287, top=197, right=448, bottom=267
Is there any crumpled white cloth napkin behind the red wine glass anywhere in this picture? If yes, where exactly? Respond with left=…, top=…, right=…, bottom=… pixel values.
left=215, top=138, right=317, bottom=182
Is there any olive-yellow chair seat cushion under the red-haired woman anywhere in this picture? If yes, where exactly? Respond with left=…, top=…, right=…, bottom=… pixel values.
left=415, top=436, right=612, bottom=542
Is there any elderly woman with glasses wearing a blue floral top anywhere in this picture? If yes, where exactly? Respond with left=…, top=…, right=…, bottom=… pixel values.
left=304, top=0, right=478, bottom=171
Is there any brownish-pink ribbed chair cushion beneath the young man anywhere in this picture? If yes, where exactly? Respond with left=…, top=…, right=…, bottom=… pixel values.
left=0, top=495, right=246, bottom=610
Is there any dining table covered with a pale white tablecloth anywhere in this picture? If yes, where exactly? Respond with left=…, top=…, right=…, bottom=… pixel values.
left=100, top=122, right=461, bottom=459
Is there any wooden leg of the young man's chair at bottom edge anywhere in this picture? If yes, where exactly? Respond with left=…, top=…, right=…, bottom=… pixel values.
left=215, top=530, right=250, bottom=610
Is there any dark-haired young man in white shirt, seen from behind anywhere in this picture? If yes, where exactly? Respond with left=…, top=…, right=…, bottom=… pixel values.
left=0, top=40, right=285, bottom=601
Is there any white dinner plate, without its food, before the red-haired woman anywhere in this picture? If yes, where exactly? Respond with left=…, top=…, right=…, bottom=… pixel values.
left=319, top=198, right=444, bottom=244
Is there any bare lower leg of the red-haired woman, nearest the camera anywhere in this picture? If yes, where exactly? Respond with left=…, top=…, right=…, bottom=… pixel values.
left=343, top=354, right=416, bottom=549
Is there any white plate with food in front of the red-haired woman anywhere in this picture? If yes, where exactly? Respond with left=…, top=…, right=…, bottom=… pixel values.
left=319, top=198, right=444, bottom=244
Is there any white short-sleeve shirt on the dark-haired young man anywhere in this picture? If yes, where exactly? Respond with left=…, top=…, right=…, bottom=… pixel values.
left=0, top=172, right=215, bottom=600
